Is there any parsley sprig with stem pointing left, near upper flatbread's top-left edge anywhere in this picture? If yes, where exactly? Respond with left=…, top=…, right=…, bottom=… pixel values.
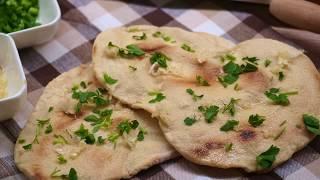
left=108, top=42, right=145, bottom=59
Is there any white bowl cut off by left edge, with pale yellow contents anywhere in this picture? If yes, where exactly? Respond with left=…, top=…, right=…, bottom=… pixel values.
left=0, top=33, right=27, bottom=121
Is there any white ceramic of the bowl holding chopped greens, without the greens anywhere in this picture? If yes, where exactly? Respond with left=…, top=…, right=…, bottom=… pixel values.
left=9, top=0, right=61, bottom=49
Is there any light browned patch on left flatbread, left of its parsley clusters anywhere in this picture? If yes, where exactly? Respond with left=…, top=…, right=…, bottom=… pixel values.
left=53, top=111, right=75, bottom=130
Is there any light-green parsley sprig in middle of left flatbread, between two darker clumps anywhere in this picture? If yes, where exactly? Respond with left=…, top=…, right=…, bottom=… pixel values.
left=84, top=109, right=113, bottom=133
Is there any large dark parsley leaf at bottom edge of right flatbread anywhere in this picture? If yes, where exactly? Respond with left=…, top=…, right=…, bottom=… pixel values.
left=256, top=145, right=280, bottom=169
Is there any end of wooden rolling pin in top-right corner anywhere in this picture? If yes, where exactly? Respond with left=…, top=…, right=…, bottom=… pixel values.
left=269, top=0, right=320, bottom=33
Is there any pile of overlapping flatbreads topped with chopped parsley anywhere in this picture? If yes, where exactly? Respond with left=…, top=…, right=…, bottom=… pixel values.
left=15, top=26, right=320, bottom=179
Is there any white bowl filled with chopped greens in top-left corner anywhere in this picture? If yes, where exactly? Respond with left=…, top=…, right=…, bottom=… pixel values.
left=0, top=0, right=61, bottom=48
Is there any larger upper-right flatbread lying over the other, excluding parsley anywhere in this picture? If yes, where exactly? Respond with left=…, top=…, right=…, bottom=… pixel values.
left=93, top=25, right=320, bottom=172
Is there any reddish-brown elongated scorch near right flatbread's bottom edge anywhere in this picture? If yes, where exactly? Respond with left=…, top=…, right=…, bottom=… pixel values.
left=192, top=141, right=224, bottom=157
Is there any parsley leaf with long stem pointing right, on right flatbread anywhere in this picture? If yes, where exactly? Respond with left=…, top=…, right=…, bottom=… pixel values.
left=264, top=88, right=298, bottom=106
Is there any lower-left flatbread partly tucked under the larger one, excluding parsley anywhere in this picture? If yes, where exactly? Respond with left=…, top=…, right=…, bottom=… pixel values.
left=15, top=65, right=177, bottom=179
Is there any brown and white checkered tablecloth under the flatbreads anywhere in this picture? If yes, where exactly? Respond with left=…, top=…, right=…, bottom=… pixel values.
left=0, top=0, right=320, bottom=180
